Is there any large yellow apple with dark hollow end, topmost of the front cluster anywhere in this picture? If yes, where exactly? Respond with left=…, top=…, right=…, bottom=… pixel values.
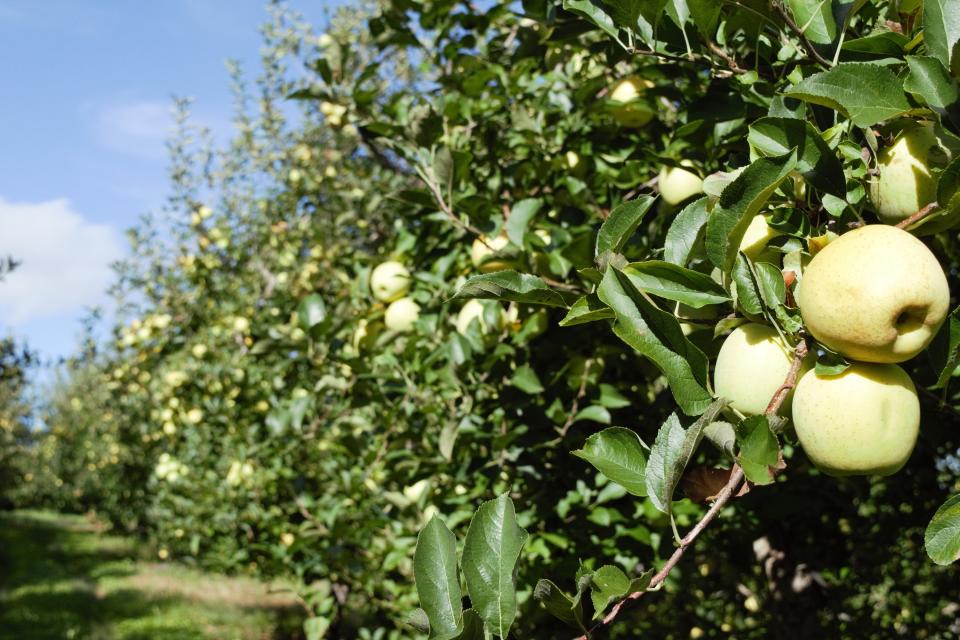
left=798, top=224, right=950, bottom=362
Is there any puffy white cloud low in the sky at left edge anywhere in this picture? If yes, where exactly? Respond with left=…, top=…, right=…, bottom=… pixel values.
left=0, top=198, right=124, bottom=326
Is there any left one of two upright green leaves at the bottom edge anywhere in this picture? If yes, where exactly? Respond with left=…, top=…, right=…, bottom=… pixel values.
left=413, top=516, right=463, bottom=639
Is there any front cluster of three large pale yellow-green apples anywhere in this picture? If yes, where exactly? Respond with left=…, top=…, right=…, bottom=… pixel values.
left=714, top=225, right=950, bottom=476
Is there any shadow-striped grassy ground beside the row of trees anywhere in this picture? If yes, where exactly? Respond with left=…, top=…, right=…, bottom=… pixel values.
left=0, top=511, right=300, bottom=640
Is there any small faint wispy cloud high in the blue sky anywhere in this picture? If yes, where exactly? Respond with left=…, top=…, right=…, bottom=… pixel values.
left=95, top=100, right=173, bottom=157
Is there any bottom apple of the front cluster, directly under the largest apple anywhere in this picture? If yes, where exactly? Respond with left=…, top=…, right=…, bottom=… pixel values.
left=793, top=362, right=920, bottom=476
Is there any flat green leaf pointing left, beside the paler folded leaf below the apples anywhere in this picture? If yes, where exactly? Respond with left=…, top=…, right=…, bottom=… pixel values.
left=573, top=427, right=647, bottom=497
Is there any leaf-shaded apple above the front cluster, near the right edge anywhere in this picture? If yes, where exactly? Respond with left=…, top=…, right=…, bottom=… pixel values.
left=870, top=122, right=949, bottom=224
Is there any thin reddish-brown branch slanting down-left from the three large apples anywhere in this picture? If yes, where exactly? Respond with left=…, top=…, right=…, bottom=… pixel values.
left=576, top=340, right=808, bottom=640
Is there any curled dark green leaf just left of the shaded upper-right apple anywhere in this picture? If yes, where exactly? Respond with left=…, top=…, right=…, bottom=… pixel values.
left=747, top=118, right=847, bottom=198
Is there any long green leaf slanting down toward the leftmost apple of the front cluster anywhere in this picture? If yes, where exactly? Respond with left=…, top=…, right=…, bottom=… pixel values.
left=597, top=267, right=710, bottom=415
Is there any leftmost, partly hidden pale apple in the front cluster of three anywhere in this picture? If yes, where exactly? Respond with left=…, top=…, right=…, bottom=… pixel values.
left=713, top=323, right=808, bottom=416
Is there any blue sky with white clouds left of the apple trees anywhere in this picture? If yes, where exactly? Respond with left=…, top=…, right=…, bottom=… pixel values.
left=0, top=0, right=334, bottom=358
